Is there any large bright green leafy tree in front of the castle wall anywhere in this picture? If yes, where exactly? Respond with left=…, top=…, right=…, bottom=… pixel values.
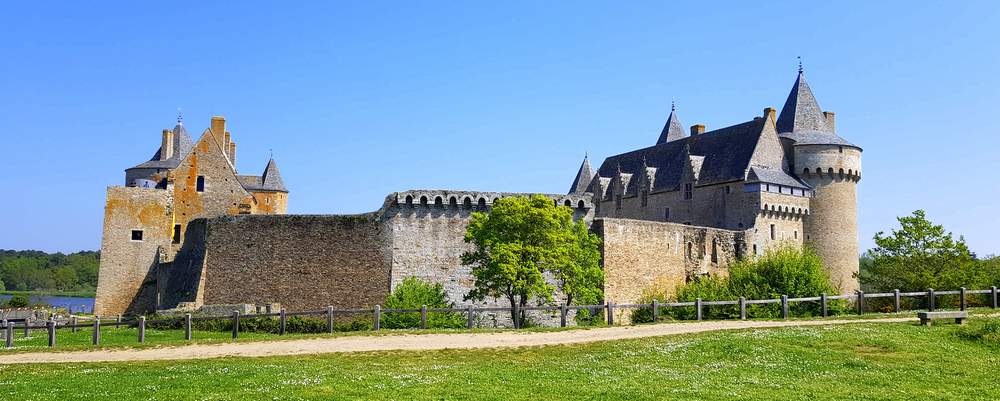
left=462, top=195, right=603, bottom=322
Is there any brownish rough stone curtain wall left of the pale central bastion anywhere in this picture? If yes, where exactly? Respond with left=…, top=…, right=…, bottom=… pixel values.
left=203, top=214, right=389, bottom=311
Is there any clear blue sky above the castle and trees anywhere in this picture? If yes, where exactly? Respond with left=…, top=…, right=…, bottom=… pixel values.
left=0, top=1, right=1000, bottom=254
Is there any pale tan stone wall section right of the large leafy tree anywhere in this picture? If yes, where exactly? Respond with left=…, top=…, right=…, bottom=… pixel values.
left=591, top=218, right=746, bottom=322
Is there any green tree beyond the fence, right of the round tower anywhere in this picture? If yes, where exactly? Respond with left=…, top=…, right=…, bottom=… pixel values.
left=859, top=210, right=983, bottom=291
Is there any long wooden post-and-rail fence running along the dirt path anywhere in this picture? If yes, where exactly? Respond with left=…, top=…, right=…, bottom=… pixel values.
left=0, top=286, right=998, bottom=348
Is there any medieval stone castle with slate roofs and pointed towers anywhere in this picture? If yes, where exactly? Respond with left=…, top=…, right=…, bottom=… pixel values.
left=95, top=69, right=861, bottom=322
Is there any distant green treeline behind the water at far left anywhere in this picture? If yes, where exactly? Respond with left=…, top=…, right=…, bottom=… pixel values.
left=0, top=249, right=101, bottom=292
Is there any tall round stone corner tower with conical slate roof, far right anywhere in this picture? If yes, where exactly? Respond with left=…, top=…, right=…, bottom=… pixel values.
left=776, top=67, right=861, bottom=293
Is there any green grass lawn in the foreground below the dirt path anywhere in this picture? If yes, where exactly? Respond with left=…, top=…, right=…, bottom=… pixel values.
left=0, top=318, right=1000, bottom=401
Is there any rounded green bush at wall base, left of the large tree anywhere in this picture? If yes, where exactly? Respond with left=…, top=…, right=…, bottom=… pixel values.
left=382, top=277, right=466, bottom=329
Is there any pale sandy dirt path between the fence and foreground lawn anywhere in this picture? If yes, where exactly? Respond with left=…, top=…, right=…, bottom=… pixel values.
left=0, top=317, right=915, bottom=364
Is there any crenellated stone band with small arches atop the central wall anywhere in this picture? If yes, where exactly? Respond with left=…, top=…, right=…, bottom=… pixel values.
left=387, top=189, right=593, bottom=211
